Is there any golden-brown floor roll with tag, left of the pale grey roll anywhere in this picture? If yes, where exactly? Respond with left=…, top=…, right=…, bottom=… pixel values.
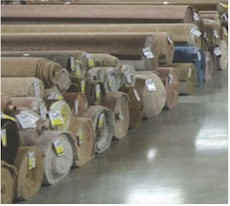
left=16, top=146, right=43, bottom=200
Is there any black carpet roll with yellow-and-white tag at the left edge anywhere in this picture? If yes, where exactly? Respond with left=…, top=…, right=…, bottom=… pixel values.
left=1, top=115, right=20, bottom=164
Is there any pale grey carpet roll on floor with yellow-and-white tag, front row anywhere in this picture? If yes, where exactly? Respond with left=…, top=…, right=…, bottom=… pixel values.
left=40, top=131, right=74, bottom=185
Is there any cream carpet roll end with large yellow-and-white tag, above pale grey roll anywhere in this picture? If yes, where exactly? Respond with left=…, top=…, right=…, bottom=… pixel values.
left=49, top=100, right=72, bottom=130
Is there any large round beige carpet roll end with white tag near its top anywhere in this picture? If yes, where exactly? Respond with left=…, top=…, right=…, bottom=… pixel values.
left=135, top=71, right=167, bottom=118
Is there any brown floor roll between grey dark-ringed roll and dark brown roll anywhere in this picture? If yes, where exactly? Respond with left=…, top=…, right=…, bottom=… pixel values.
left=102, top=92, right=130, bottom=139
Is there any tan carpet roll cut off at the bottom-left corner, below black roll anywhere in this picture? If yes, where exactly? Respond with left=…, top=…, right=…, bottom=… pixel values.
left=1, top=160, right=17, bottom=204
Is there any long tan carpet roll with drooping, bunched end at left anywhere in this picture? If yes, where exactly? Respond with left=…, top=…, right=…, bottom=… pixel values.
left=1, top=57, right=70, bottom=91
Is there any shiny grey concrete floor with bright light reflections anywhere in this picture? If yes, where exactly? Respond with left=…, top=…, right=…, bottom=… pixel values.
left=26, top=71, right=228, bottom=204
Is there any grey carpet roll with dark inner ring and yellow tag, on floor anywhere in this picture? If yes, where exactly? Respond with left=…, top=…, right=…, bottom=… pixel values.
left=83, top=105, right=114, bottom=154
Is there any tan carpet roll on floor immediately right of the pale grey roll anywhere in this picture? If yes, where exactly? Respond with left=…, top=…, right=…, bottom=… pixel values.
left=69, top=116, right=96, bottom=167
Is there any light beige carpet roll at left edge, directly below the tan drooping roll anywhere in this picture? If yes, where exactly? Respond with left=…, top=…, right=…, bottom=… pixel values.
left=1, top=77, right=45, bottom=98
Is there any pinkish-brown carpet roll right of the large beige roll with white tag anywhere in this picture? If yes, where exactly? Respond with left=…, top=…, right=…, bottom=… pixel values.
left=158, top=67, right=179, bottom=109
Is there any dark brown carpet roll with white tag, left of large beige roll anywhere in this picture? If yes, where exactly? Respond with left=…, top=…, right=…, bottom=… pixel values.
left=121, top=87, right=144, bottom=129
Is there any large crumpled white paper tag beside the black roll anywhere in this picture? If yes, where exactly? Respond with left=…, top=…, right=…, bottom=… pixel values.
left=16, top=111, right=39, bottom=129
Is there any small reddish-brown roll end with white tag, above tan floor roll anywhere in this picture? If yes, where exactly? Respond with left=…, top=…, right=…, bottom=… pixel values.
left=64, top=92, right=89, bottom=116
